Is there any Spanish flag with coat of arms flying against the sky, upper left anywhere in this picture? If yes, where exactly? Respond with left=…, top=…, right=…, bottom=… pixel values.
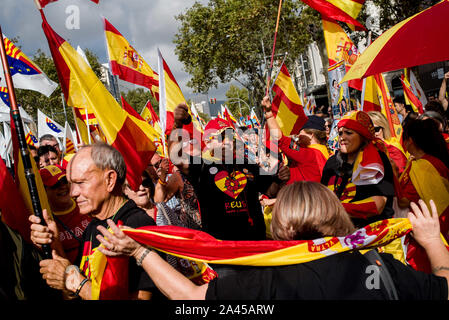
left=104, top=19, right=159, bottom=101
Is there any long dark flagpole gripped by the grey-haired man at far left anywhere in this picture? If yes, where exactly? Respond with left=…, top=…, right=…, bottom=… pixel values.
left=0, top=26, right=52, bottom=259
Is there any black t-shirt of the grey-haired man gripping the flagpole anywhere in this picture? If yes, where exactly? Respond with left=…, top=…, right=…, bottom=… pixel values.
left=78, top=200, right=157, bottom=292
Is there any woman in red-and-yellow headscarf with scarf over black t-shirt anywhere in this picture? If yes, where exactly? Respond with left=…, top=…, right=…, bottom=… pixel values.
left=321, top=111, right=395, bottom=227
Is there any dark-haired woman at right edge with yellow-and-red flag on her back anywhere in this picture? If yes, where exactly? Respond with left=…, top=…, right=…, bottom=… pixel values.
left=399, top=119, right=449, bottom=272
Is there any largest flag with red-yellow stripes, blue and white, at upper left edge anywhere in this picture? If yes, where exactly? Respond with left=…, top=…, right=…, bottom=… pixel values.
left=0, top=36, right=58, bottom=97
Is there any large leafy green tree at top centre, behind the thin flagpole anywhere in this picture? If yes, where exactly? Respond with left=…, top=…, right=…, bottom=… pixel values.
left=174, top=0, right=321, bottom=109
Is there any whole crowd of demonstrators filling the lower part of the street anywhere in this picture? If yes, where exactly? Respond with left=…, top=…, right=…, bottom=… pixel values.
left=0, top=90, right=449, bottom=300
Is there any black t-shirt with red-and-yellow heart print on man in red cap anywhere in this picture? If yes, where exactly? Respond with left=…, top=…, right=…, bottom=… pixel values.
left=187, top=158, right=274, bottom=240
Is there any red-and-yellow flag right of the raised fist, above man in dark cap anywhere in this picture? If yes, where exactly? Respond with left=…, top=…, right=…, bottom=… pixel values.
left=271, top=64, right=307, bottom=136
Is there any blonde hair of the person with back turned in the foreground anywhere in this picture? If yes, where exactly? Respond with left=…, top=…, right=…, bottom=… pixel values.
left=271, top=181, right=355, bottom=240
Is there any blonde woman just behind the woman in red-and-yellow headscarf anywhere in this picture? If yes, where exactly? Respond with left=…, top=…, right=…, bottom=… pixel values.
left=368, top=111, right=407, bottom=177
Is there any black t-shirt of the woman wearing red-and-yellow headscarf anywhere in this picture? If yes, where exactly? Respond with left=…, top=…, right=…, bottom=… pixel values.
left=321, top=151, right=395, bottom=228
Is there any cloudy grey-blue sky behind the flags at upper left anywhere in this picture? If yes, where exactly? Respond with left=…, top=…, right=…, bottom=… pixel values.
left=0, top=0, right=229, bottom=102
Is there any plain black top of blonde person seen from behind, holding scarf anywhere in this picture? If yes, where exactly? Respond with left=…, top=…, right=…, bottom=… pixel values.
left=206, top=251, right=448, bottom=300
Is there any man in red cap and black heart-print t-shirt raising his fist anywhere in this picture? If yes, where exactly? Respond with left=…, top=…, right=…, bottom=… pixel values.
left=169, top=104, right=290, bottom=240
